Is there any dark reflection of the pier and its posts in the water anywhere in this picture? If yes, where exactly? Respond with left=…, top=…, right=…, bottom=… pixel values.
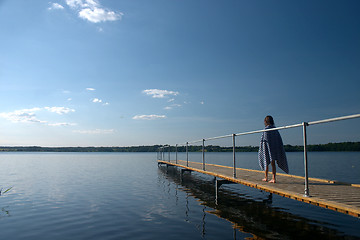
left=159, top=166, right=358, bottom=239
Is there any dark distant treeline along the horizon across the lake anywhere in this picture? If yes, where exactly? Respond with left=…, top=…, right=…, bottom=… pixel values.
left=0, top=142, right=360, bottom=152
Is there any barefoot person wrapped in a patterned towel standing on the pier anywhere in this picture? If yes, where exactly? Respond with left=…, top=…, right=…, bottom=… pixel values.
left=259, top=116, right=289, bottom=183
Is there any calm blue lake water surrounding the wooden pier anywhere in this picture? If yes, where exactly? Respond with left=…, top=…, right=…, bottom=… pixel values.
left=0, top=153, right=360, bottom=239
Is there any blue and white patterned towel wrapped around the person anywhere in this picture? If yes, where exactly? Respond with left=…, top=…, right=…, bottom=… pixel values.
left=258, top=126, right=289, bottom=173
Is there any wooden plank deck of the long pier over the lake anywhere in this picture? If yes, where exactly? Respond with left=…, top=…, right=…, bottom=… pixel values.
left=158, top=160, right=360, bottom=217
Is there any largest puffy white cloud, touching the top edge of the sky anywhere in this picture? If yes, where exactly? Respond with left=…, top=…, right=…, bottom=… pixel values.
left=66, top=0, right=124, bottom=23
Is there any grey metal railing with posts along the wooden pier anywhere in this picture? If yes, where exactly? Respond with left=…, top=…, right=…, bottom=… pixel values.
left=157, top=114, right=360, bottom=197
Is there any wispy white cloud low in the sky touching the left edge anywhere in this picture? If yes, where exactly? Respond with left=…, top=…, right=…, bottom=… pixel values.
left=0, top=107, right=75, bottom=126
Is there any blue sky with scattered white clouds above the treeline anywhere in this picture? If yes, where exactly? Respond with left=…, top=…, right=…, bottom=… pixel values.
left=0, top=0, right=360, bottom=147
